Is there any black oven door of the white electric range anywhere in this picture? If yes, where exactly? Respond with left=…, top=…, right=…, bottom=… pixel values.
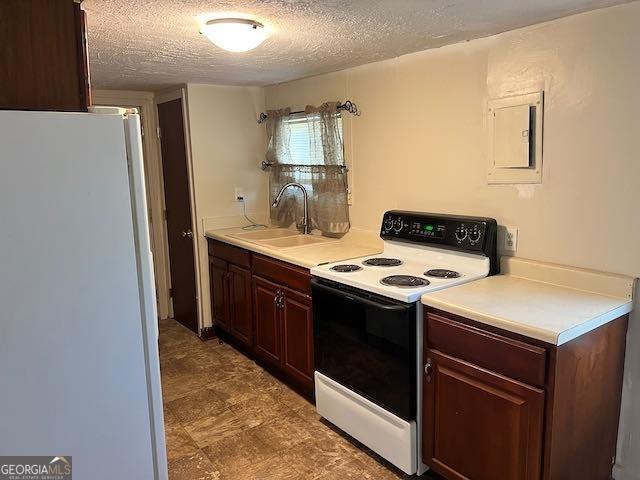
left=311, top=278, right=416, bottom=420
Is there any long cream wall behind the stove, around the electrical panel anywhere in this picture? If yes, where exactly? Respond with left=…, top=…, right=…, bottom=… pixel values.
left=266, top=2, right=640, bottom=479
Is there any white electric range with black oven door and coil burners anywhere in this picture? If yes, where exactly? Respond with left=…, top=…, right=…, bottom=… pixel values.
left=311, top=211, right=498, bottom=474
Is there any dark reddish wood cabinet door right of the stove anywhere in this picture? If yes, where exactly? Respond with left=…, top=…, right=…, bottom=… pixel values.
left=422, top=349, right=544, bottom=480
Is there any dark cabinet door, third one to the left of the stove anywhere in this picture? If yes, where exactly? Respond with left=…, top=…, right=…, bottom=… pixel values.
left=229, top=264, right=253, bottom=345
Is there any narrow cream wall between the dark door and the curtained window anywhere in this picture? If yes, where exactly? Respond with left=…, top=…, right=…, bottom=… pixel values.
left=187, top=84, right=268, bottom=326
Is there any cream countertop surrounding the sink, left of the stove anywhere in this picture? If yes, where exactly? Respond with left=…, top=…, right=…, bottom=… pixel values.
left=205, top=227, right=383, bottom=268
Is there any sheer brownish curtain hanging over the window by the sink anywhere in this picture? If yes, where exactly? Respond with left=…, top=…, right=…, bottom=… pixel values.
left=267, top=102, right=350, bottom=236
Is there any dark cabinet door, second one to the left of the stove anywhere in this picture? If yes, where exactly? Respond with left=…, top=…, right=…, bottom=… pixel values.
left=253, top=276, right=280, bottom=367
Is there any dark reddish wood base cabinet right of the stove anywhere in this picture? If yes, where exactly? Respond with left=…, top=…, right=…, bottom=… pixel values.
left=422, top=308, right=627, bottom=480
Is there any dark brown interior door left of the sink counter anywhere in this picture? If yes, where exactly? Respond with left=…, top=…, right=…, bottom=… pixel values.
left=158, top=99, right=198, bottom=333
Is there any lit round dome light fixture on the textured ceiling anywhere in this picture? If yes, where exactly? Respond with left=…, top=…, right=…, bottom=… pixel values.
left=200, top=18, right=269, bottom=52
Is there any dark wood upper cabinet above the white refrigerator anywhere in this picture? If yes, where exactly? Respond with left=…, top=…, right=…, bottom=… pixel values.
left=0, top=0, right=91, bottom=112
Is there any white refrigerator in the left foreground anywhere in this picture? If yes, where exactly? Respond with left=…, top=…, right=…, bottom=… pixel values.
left=0, top=111, right=167, bottom=480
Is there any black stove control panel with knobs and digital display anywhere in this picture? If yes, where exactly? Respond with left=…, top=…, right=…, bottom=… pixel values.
left=380, top=210, right=497, bottom=270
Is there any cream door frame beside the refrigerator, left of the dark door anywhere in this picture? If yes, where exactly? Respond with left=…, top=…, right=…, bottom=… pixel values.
left=92, top=89, right=173, bottom=318
